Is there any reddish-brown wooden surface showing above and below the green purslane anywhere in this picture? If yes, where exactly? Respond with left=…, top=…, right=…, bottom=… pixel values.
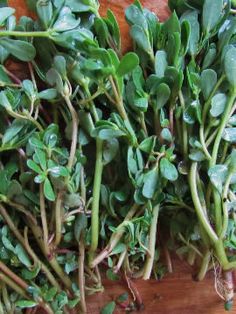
left=5, top=0, right=236, bottom=314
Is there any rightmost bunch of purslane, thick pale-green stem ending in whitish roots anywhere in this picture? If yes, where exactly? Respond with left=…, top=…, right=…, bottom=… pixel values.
left=126, top=0, right=236, bottom=308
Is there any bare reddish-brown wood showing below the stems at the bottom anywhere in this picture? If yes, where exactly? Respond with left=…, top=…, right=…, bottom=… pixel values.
left=88, top=260, right=236, bottom=314
